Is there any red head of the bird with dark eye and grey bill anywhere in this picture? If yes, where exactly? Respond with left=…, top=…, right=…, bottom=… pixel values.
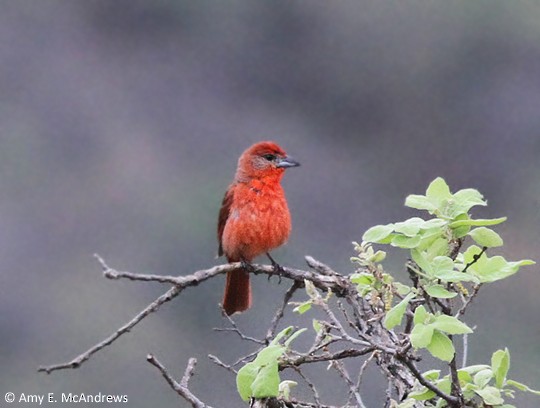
left=236, top=142, right=300, bottom=181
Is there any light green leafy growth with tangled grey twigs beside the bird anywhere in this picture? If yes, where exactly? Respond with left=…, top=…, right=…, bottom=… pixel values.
left=237, top=177, right=540, bottom=408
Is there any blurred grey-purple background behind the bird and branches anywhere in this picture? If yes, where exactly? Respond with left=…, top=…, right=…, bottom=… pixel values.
left=0, top=0, right=540, bottom=408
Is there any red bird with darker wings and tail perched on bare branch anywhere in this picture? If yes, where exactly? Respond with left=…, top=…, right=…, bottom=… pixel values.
left=218, top=142, right=300, bottom=315
